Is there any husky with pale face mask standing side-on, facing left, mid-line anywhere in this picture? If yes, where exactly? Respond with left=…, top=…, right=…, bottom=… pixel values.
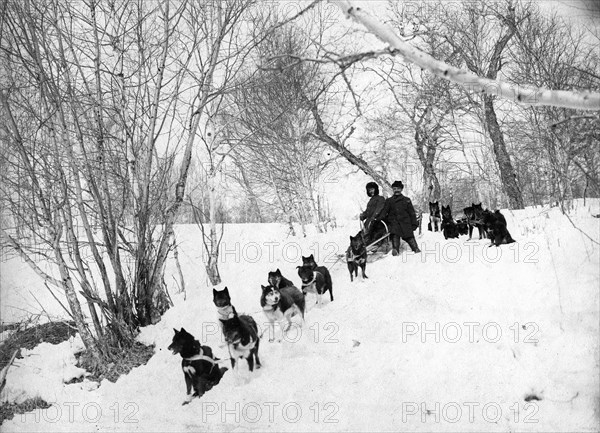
left=260, top=285, right=305, bottom=342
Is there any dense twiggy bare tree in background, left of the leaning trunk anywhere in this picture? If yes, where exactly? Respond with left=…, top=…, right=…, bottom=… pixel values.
left=230, top=21, right=338, bottom=232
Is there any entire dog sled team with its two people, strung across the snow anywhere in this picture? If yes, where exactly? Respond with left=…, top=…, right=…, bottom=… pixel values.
left=168, top=177, right=514, bottom=404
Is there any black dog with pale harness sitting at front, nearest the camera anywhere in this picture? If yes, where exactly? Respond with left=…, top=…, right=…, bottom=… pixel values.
left=168, top=328, right=227, bottom=404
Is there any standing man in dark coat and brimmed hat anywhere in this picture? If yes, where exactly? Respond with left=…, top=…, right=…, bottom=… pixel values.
left=379, top=180, right=421, bottom=256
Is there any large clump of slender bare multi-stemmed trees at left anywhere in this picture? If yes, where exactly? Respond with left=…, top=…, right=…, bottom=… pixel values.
left=0, top=0, right=274, bottom=363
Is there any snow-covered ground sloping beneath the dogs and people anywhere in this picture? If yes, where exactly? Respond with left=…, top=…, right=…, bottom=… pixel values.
left=1, top=201, right=600, bottom=432
